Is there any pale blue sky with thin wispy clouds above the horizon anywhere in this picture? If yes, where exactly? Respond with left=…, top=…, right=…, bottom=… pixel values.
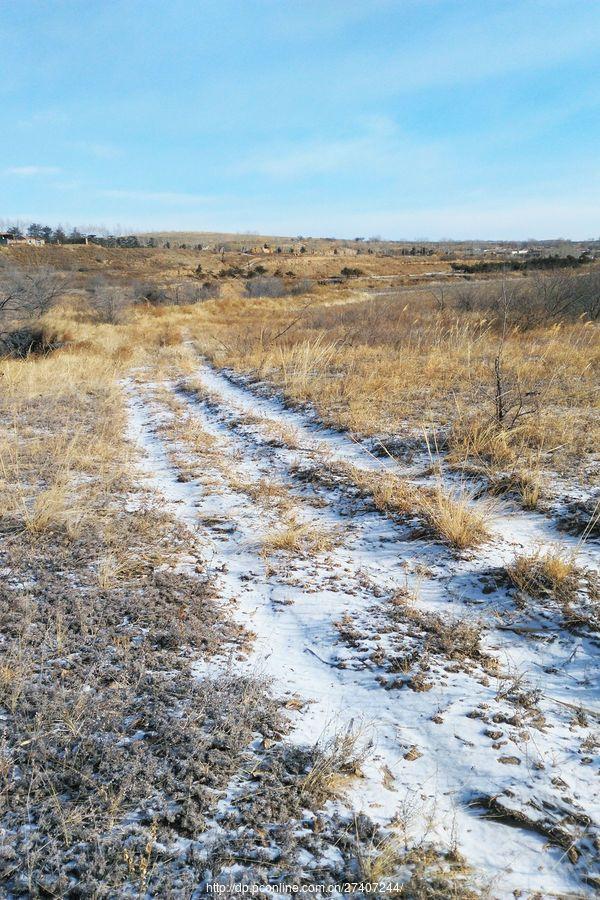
left=0, top=0, right=600, bottom=239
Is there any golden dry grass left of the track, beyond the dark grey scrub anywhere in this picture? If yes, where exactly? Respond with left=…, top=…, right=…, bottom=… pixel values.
left=0, top=305, right=202, bottom=572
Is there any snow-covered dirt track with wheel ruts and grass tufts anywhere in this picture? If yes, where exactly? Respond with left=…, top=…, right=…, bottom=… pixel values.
left=128, top=366, right=598, bottom=897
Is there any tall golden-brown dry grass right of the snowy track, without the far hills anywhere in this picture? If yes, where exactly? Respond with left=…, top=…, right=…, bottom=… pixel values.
left=173, top=288, right=600, bottom=505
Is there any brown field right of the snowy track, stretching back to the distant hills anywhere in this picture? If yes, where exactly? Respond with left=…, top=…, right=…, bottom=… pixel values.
left=1, top=243, right=600, bottom=506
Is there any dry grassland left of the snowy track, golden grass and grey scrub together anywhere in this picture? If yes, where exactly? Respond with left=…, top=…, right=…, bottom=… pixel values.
left=0, top=308, right=482, bottom=897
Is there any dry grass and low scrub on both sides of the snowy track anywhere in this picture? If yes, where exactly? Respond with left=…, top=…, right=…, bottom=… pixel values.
left=0, top=248, right=600, bottom=898
